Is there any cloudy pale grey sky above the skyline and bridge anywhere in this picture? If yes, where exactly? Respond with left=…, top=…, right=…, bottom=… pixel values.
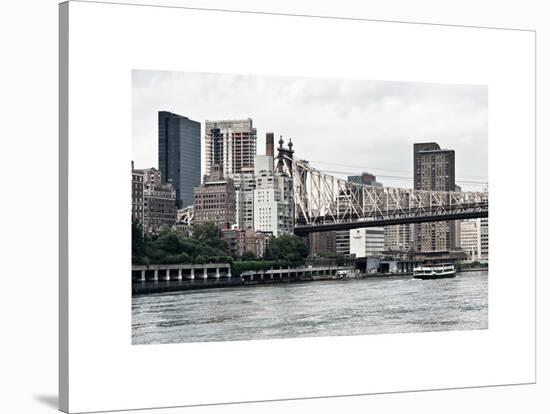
left=132, top=70, right=488, bottom=190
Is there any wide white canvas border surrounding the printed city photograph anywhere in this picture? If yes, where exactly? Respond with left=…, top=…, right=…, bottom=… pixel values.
left=61, top=2, right=534, bottom=411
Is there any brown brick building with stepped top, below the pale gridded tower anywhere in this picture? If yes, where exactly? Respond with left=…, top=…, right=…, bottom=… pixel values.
left=193, top=167, right=237, bottom=229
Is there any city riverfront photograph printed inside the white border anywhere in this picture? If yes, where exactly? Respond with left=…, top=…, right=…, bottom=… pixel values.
left=132, top=70, right=489, bottom=345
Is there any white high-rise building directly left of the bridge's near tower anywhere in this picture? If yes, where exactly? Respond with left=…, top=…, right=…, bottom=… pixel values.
left=254, top=155, right=294, bottom=237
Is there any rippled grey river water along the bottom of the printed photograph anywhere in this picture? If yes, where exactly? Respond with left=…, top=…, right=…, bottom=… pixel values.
left=132, top=271, right=488, bottom=344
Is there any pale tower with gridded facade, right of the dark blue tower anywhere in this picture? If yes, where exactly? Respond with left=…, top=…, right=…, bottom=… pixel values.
left=204, top=118, right=256, bottom=176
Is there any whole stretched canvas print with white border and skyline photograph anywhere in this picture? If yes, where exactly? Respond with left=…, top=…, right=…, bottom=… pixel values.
left=59, top=0, right=536, bottom=413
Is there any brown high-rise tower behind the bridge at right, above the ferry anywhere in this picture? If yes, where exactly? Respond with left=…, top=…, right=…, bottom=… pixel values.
left=413, top=142, right=456, bottom=252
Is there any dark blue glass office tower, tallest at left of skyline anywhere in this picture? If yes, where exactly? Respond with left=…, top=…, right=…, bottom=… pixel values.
left=159, top=111, right=201, bottom=208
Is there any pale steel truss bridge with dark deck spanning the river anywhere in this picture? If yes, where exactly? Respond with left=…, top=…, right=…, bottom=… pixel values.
left=276, top=152, right=489, bottom=235
